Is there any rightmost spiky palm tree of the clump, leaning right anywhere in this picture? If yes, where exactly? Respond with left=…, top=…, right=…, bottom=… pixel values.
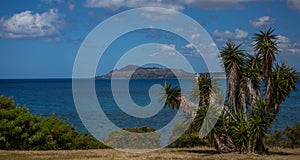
left=273, top=62, right=297, bottom=115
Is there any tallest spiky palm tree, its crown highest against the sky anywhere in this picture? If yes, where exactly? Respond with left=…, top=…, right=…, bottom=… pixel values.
left=254, top=28, right=278, bottom=111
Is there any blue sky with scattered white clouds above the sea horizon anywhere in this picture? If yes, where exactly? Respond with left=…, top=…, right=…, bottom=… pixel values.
left=0, top=0, right=300, bottom=79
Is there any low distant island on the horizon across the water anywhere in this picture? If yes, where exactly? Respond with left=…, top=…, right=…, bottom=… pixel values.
left=96, top=65, right=225, bottom=79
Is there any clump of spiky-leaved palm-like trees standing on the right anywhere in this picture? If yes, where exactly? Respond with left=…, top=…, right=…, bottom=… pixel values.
left=164, top=28, right=298, bottom=154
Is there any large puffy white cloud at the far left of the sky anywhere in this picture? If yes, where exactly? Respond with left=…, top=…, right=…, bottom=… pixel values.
left=0, top=9, right=62, bottom=38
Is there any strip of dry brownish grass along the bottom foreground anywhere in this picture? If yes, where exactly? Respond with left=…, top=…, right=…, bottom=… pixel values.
left=0, top=147, right=300, bottom=160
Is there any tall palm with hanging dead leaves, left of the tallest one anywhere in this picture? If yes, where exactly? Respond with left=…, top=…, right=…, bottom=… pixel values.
left=220, top=41, right=245, bottom=113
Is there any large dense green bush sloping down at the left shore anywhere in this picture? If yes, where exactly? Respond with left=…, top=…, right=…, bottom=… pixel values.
left=0, top=95, right=106, bottom=150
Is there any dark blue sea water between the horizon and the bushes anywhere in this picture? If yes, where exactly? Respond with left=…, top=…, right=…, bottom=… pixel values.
left=0, top=79, right=300, bottom=131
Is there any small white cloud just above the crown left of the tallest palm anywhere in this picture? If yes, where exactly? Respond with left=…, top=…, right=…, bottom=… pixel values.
left=213, top=28, right=249, bottom=42
